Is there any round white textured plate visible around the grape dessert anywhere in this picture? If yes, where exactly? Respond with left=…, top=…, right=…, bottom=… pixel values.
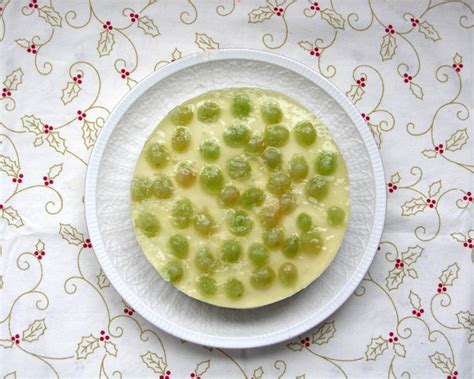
left=85, top=50, right=386, bottom=348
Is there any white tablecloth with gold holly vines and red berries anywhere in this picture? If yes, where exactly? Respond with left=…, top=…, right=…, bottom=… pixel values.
left=0, top=0, right=474, bottom=379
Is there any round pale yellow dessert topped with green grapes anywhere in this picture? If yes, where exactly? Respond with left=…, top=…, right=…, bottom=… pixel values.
left=131, top=88, right=350, bottom=308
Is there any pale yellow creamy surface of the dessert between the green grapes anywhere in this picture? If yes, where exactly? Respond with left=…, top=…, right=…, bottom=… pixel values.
left=131, top=89, right=350, bottom=308
